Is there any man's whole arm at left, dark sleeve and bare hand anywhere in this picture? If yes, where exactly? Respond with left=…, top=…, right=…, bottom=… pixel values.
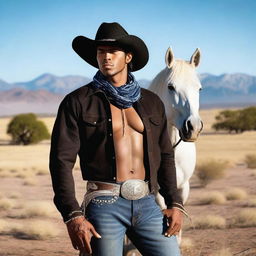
left=50, top=93, right=101, bottom=253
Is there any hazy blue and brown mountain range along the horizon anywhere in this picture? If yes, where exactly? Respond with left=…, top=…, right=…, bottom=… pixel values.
left=0, top=73, right=256, bottom=115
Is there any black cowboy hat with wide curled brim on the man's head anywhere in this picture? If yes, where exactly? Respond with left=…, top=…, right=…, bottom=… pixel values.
left=72, top=22, right=148, bottom=71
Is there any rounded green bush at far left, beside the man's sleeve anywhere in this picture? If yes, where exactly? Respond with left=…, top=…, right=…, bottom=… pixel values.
left=7, top=113, right=50, bottom=145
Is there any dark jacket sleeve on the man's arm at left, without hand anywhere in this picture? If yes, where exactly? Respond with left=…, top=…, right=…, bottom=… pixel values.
left=50, top=95, right=81, bottom=221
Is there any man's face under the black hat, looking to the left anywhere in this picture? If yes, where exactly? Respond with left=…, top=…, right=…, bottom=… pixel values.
left=97, top=46, right=132, bottom=80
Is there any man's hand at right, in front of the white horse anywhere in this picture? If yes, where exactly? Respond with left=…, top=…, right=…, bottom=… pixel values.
left=163, top=208, right=183, bottom=236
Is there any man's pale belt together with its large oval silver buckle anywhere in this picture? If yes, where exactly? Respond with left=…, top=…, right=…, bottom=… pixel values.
left=87, top=179, right=149, bottom=200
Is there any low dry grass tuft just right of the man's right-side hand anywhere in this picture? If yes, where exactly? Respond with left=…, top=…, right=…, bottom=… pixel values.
left=189, top=215, right=226, bottom=229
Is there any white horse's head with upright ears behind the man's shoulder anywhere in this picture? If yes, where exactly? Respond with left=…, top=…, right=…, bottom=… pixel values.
left=149, top=48, right=203, bottom=142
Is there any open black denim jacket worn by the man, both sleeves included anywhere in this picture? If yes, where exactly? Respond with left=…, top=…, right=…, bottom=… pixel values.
left=50, top=83, right=182, bottom=221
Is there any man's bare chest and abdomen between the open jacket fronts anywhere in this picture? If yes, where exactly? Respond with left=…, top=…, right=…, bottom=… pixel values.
left=110, top=104, right=145, bottom=182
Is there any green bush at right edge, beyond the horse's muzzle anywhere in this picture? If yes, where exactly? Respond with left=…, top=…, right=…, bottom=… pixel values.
left=212, top=107, right=256, bottom=133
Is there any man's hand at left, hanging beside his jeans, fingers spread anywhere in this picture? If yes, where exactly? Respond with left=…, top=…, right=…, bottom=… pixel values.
left=67, top=216, right=101, bottom=254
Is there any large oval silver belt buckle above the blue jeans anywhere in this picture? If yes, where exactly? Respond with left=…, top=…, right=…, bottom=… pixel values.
left=120, top=179, right=148, bottom=200
